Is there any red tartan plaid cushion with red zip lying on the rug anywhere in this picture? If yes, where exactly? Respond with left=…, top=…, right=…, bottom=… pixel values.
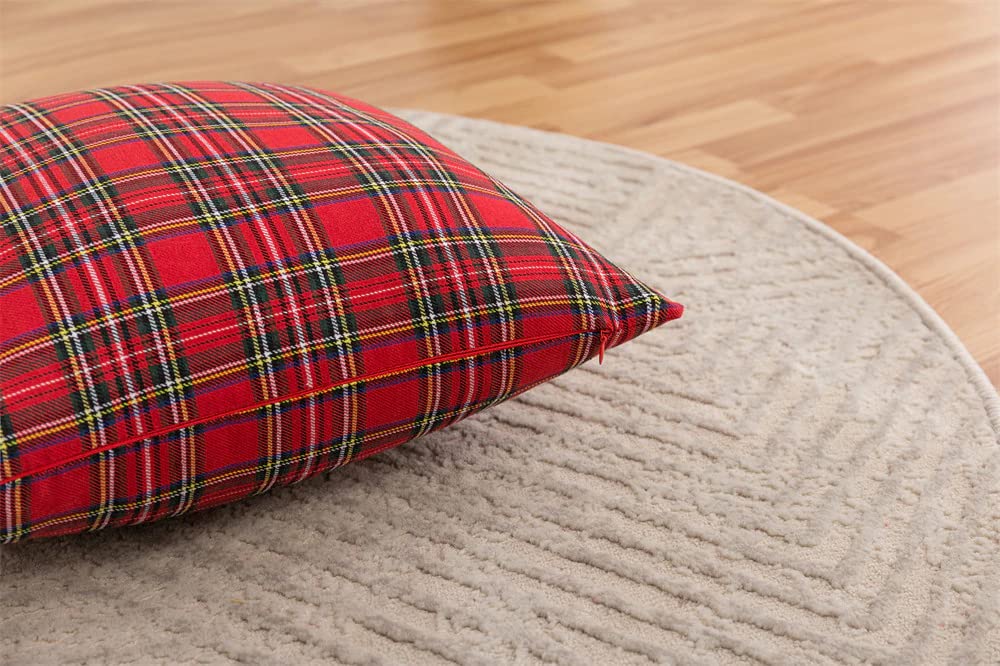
left=0, top=82, right=682, bottom=542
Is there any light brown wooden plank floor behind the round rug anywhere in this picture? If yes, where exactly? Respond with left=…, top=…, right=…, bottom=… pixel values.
left=0, top=0, right=1000, bottom=384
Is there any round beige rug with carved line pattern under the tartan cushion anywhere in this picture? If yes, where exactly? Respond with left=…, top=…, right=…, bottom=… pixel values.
left=0, top=113, right=1000, bottom=664
